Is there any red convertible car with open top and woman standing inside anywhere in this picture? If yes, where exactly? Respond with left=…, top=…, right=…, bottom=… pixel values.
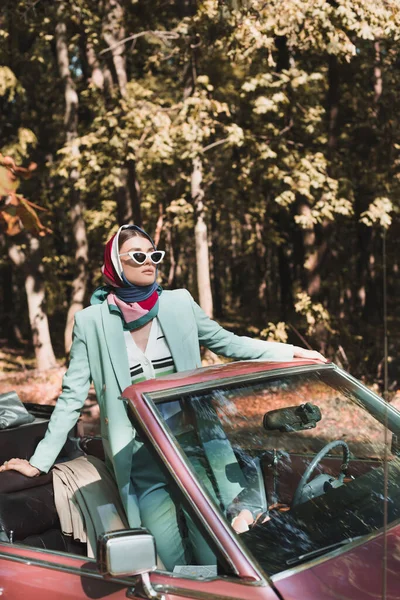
left=0, top=361, right=400, bottom=600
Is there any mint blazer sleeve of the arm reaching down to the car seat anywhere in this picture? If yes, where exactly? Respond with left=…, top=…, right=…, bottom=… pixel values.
left=29, top=315, right=91, bottom=473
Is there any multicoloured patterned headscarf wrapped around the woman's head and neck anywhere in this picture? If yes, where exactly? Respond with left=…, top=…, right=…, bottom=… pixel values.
left=90, top=225, right=162, bottom=331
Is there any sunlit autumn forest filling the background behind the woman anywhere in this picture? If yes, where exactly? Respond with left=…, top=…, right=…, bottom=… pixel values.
left=0, top=0, right=400, bottom=389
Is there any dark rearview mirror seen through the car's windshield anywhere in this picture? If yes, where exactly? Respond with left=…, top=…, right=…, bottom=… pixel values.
left=263, top=402, right=321, bottom=432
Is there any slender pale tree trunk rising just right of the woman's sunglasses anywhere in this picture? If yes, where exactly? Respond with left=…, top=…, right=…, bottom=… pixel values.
left=191, top=156, right=213, bottom=318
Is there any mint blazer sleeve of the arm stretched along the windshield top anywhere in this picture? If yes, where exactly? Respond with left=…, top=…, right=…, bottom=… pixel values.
left=188, top=292, right=293, bottom=361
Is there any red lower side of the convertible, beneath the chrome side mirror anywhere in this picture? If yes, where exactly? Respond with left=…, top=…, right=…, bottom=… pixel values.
left=0, top=542, right=284, bottom=600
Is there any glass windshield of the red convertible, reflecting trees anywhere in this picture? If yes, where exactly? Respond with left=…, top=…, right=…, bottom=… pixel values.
left=152, top=367, right=400, bottom=575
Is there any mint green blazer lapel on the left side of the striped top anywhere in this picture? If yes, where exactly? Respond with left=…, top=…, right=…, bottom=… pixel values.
left=101, top=301, right=131, bottom=392
